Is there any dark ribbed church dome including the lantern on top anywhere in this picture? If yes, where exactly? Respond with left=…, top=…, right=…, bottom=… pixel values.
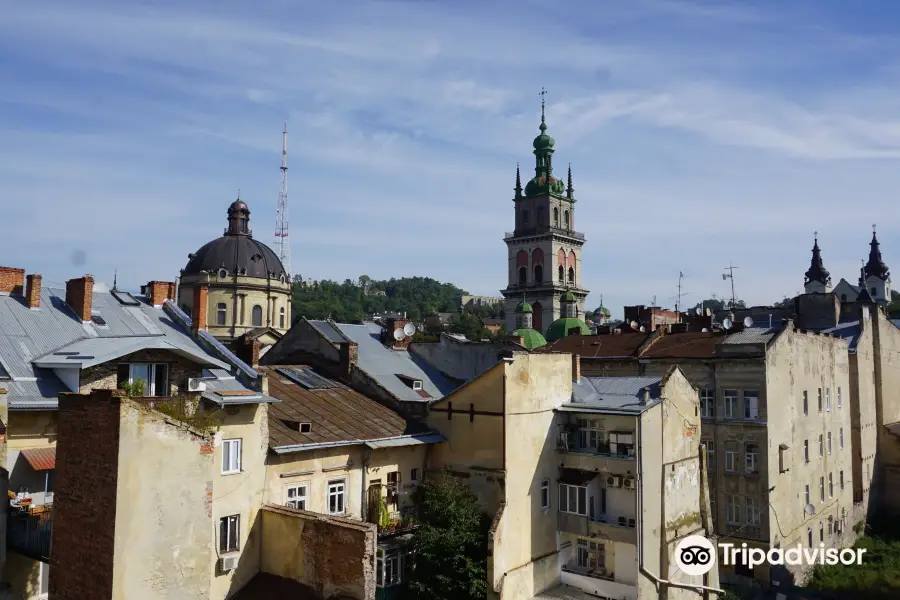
left=182, top=198, right=287, bottom=279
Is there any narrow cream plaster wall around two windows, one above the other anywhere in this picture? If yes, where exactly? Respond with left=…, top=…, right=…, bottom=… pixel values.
left=207, top=404, right=269, bottom=598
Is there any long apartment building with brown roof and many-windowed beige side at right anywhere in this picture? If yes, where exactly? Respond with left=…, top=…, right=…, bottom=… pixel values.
left=548, top=321, right=855, bottom=584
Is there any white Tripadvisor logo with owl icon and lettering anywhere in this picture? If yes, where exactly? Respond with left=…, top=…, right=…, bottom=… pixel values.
left=675, top=535, right=866, bottom=575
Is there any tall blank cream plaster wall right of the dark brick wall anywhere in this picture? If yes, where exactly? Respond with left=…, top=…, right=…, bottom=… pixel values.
left=111, top=401, right=210, bottom=600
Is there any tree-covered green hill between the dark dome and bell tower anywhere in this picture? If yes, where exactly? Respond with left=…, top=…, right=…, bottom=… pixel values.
left=292, top=275, right=488, bottom=323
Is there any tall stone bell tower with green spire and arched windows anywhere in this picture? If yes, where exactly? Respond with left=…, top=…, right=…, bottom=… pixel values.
left=500, top=90, right=588, bottom=333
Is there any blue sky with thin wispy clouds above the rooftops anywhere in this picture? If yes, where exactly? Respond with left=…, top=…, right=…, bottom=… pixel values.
left=0, top=0, right=900, bottom=314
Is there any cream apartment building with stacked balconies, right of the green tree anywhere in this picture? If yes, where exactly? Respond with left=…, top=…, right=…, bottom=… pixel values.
left=429, top=352, right=718, bottom=600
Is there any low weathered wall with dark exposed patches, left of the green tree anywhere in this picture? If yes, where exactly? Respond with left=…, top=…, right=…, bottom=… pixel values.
left=260, top=505, right=377, bottom=600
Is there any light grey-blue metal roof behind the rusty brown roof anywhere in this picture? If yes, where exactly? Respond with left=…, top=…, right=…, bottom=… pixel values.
left=311, top=321, right=457, bottom=402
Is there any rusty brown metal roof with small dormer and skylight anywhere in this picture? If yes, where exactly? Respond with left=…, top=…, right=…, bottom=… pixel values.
left=265, top=365, right=427, bottom=448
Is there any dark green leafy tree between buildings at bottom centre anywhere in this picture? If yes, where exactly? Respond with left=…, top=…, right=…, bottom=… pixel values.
left=408, top=474, right=491, bottom=600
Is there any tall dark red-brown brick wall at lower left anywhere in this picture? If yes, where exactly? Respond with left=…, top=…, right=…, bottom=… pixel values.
left=50, top=391, right=120, bottom=600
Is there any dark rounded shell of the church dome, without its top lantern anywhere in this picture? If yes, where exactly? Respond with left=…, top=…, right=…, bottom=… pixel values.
left=182, top=235, right=287, bottom=279
